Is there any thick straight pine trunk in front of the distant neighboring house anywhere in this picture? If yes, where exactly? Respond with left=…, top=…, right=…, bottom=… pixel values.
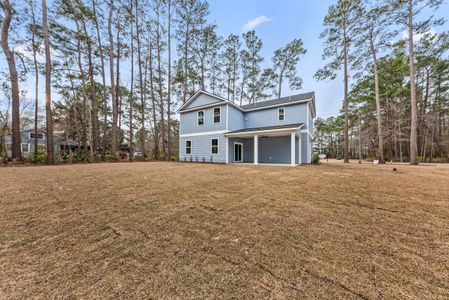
left=42, top=0, right=55, bottom=164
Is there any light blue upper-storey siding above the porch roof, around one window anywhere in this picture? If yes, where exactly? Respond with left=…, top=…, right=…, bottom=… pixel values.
left=245, top=103, right=308, bottom=128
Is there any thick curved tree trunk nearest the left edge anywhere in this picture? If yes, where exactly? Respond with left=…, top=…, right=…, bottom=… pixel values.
left=1, top=0, right=21, bottom=160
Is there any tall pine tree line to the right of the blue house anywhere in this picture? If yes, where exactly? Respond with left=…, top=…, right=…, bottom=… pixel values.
left=315, top=0, right=449, bottom=164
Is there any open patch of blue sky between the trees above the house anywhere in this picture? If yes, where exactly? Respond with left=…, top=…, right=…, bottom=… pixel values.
left=209, top=0, right=449, bottom=118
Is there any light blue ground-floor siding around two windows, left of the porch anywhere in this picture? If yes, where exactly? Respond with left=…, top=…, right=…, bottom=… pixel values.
left=179, top=134, right=226, bottom=163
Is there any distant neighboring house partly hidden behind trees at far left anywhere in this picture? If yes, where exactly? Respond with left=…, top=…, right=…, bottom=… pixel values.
left=5, top=129, right=79, bottom=158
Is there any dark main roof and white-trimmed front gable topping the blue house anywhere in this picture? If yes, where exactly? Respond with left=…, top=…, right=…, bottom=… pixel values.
left=178, top=90, right=316, bottom=117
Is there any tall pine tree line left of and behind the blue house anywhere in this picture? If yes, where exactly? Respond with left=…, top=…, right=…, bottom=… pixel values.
left=0, top=0, right=306, bottom=163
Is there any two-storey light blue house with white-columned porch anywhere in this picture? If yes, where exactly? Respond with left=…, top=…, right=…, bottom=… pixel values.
left=178, top=91, right=316, bottom=165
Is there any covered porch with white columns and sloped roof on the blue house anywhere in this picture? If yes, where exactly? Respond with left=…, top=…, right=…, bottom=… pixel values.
left=225, top=123, right=303, bottom=166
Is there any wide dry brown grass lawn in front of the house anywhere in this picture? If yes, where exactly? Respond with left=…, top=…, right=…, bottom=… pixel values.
left=0, top=163, right=449, bottom=299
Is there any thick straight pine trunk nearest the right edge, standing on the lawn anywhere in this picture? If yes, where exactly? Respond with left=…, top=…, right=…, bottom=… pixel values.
left=408, top=0, right=418, bottom=165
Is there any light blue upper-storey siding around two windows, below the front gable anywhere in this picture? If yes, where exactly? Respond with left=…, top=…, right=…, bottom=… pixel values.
left=180, top=105, right=226, bottom=134
